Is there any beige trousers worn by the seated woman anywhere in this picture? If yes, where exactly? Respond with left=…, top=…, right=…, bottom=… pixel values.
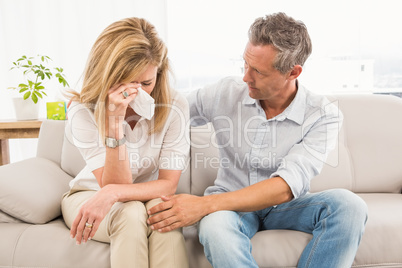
left=62, top=191, right=188, bottom=268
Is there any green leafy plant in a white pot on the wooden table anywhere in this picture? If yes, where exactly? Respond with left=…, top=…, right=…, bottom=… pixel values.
left=9, top=55, right=69, bottom=120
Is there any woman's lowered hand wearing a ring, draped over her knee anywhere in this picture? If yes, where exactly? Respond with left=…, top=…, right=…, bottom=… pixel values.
left=70, top=185, right=117, bottom=245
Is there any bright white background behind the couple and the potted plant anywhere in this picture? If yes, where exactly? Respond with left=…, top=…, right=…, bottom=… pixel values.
left=0, top=0, right=402, bottom=161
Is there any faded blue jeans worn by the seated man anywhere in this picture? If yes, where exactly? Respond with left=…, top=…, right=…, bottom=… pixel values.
left=198, top=189, right=367, bottom=268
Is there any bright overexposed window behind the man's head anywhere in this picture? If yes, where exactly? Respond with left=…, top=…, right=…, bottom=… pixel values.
left=167, top=0, right=402, bottom=94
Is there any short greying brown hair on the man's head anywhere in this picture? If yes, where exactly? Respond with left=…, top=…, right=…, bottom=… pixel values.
left=248, top=13, right=312, bottom=74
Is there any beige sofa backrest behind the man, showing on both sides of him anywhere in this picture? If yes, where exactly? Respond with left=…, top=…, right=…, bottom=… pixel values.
left=190, top=95, right=402, bottom=195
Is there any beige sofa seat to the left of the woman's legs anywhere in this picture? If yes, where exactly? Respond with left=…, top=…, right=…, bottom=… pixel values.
left=0, top=218, right=110, bottom=268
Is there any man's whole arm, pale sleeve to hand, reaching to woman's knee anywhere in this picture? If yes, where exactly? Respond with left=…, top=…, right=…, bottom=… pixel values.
left=148, top=97, right=342, bottom=232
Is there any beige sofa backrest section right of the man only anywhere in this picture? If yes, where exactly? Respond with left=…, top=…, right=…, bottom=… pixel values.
left=312, top=94, right=402, bottom=193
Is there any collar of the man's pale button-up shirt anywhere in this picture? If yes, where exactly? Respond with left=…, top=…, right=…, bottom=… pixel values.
left=242, top=80, right=307, bottom=125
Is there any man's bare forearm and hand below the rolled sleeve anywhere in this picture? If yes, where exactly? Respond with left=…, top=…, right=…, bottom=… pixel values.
left=148, top=177, right=293, bottom=232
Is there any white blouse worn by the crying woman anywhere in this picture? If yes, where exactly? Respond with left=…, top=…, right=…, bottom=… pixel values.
left=66, top=92, right=190, bottom=191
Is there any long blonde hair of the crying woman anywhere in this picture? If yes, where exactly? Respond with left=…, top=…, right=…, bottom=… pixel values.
left=72, top=18, right=171, bottom=140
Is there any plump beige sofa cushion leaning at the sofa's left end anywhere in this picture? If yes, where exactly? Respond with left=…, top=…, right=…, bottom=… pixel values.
left=0, top=157, right=71, bottom=223
